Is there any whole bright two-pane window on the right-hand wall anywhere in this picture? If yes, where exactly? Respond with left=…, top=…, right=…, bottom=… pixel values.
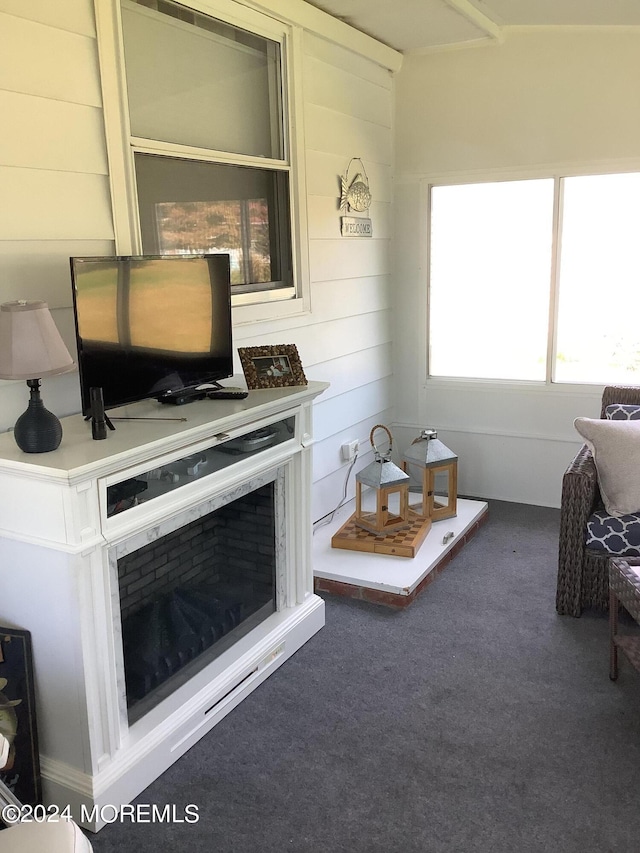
left=429, top=173, right=640, bottom=384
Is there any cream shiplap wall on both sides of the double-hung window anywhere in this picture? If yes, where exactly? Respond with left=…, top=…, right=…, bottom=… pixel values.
left=0, top=0, right=393, bottom=517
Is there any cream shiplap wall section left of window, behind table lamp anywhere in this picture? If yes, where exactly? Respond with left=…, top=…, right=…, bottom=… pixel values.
left=0, top=0, right=114, bottom=430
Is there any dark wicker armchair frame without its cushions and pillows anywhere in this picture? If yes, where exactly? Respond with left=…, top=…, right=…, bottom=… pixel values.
left=556, top=385, right=640, bottom=616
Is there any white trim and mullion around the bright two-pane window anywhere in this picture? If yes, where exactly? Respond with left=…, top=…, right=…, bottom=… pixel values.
left=419, top=158, right=640, bottom=395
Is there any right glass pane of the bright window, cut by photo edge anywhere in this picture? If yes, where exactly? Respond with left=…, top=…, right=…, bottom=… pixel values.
left=554, top=173, right=640, bottom=385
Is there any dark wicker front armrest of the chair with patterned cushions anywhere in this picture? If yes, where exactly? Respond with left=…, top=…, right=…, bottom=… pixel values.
left=556, top=445, right=600, bottom=616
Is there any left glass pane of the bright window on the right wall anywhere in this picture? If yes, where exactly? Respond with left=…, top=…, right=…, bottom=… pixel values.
left=429, top=179, right=553, bottom=381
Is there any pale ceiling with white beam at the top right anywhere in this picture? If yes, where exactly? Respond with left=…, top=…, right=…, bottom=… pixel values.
left=307, top=0, right=640, bottom=53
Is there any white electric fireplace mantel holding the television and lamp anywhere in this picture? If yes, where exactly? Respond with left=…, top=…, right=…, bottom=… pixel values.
left=0, top=382, right=328, bottom=830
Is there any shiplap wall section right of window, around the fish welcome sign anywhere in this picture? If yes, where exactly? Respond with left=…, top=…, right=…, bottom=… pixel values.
left=235, top=32, right=392, bottom=518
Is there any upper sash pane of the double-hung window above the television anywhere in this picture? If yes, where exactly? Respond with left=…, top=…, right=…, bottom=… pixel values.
left=122, top=0, right=284, bottom=159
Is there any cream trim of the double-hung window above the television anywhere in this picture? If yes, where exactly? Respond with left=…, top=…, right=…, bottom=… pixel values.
left=94, top=0, right=311, bottom=325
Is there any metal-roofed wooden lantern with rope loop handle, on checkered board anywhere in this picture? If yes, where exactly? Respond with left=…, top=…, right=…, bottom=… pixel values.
left=355, top=424, right=411, bottom=536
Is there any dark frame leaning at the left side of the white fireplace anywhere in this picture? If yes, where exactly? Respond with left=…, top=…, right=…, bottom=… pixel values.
left=0, top=627, right=42, bottom=806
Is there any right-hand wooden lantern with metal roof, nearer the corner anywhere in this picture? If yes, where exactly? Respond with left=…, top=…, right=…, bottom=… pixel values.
left=402, top=429, right=458, bottom=521
